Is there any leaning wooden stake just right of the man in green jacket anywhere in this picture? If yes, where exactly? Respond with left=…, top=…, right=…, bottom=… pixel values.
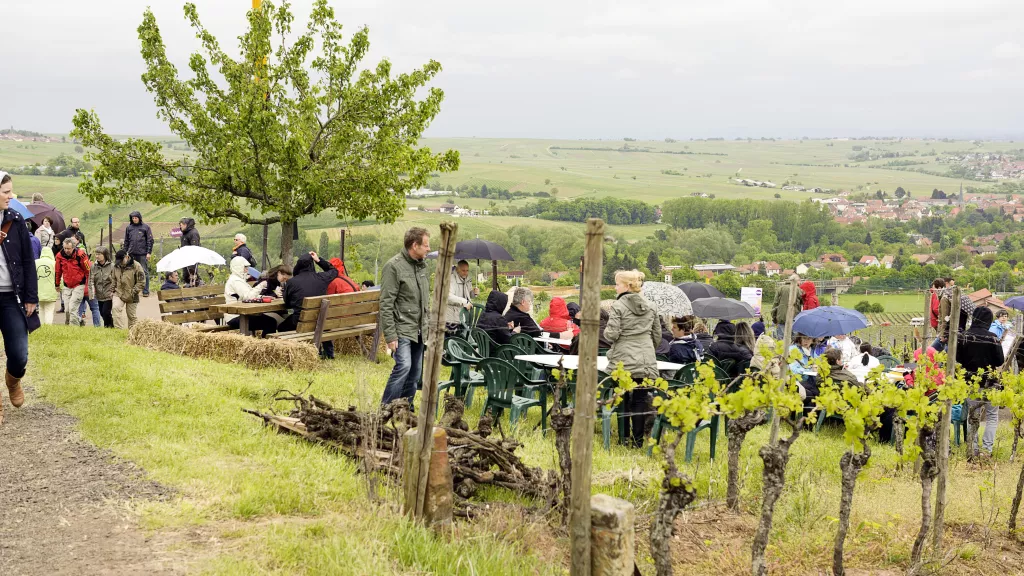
left=407, top=222, right=459, bottom=519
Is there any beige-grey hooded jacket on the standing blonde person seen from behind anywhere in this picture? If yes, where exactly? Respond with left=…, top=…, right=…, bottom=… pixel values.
left=604, top=292, right=662, bottom=379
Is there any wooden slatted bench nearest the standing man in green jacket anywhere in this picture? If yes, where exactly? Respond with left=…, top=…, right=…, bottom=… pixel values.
left=273, top=290, right=381, bottom=362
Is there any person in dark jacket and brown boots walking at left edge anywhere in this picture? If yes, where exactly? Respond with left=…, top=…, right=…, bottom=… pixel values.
left=0, top=172, right=39, bottom=423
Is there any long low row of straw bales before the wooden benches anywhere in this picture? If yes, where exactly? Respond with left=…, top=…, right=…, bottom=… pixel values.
left=128, top=320, right=319, bottom=371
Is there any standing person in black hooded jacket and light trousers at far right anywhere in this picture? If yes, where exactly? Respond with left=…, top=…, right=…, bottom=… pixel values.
left=956, top=306, right=1006, bottom=455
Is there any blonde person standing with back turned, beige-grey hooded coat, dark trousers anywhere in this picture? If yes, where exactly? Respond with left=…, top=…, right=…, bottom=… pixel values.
left=604, top=270, right=662, bottom=448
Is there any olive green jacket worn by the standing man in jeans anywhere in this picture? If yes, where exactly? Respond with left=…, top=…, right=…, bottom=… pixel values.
left=381, top=249, right=430, bottom=342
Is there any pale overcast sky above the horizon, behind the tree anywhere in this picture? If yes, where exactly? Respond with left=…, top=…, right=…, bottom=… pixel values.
left=0, top=0, right=1024, bottom=138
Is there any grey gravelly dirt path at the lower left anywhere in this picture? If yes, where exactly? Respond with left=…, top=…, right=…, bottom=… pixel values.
left=0, top=384, right=186, bottom=576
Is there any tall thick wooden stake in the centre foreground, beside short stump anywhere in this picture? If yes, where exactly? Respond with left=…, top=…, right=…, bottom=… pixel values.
left=569, top=218, right=604, bottom=576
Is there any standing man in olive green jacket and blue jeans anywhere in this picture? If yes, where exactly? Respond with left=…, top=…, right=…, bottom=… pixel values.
left=380, top=228, right=430, bottom=406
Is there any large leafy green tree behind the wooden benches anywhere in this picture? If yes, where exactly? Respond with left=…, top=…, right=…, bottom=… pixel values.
left=71, top=0, right=459, bottom=262
